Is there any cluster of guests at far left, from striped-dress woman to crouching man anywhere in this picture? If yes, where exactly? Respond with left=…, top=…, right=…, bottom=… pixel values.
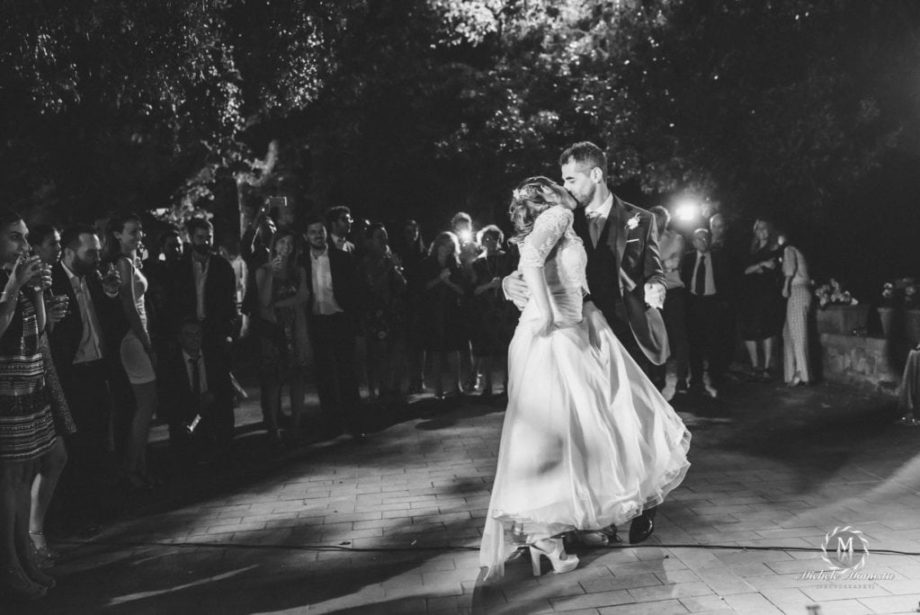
left=0, top=210, right=244, bottom=599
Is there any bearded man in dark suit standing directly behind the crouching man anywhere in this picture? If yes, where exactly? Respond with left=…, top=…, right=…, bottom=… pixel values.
left=166, top=218, right=239, bottom=353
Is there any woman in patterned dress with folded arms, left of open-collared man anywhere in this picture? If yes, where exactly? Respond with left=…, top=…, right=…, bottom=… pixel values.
left=256, top=230, right=310, bottom=442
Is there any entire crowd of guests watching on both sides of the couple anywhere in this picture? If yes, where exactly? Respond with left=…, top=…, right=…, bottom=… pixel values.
left=0, top=192, right=812, bottom=599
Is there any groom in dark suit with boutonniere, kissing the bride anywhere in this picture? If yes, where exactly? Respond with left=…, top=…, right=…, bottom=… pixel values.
left=502, top=141, right=668, bottom=544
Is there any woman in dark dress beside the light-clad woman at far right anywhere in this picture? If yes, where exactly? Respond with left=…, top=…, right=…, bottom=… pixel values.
left=741, top=220, right=785, bottom=380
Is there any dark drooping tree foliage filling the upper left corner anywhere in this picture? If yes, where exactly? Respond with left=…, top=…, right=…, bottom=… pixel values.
left=0, top=0, right=325, bottom=224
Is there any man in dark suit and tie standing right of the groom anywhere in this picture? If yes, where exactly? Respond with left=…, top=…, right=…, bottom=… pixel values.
left=681, top=228, right=732, bottom=397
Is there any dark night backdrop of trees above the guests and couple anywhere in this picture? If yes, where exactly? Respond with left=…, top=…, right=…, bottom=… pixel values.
left=0, top=0, right=920, bottom=303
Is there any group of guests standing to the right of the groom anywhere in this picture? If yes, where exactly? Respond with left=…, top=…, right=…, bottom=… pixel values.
left=651, top=207, right=813, bottom=397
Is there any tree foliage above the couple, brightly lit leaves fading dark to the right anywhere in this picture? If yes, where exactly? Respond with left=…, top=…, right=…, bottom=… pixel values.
left=434, top=0, right=920, bottom=224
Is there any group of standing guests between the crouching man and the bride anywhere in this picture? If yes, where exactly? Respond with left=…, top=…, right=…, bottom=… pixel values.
left=241, top=206, right=516, bottom=422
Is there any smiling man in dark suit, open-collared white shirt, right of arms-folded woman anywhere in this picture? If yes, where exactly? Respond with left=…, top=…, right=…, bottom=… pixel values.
left=303, top=216, right=366, bottom=440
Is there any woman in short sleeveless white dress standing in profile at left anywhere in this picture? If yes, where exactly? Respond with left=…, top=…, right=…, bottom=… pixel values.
left=105, top=214, right=157, bottom=489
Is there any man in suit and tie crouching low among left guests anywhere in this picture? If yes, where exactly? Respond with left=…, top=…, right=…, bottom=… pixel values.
left=161, top=318, right=234, bottom=468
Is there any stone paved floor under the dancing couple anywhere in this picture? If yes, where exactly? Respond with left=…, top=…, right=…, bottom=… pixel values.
left=16, top=376, right=920, bottom=615
